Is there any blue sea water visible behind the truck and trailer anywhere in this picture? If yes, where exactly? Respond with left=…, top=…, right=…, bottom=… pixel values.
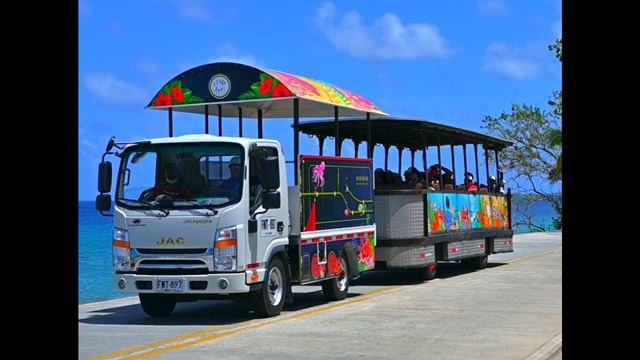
left=78, top=201, right=553, bottom=303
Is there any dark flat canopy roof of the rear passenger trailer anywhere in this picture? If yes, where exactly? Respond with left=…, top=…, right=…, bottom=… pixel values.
left=300, top=117, right=513, bottom=151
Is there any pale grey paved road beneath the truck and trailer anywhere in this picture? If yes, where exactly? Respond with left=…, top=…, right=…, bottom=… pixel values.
left=79, top=232, right=562, bottom=360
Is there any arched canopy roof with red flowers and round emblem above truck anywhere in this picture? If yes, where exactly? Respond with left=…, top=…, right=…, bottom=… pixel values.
left=147, top=62, right=386, bottom=118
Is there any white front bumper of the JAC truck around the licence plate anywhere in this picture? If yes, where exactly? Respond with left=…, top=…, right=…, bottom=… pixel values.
left=113, top=272, right=254, bottom=294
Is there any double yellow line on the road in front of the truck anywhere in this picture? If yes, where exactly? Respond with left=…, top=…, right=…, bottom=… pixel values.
left=91, top=285, right=400, bottom=360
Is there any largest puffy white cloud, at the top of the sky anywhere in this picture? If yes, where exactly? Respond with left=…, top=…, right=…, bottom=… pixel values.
left=316, top=2, right=452, bottom=60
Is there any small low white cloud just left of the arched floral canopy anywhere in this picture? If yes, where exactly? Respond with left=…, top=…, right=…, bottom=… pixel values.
left=85, top=73, right=149, bottom=106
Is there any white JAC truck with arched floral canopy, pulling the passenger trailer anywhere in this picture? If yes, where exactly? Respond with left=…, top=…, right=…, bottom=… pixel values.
left=96, top=63, right=384, bottom=316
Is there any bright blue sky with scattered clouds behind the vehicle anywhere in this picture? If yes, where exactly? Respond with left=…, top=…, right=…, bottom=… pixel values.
left=78, top=0, right=562, bottom=200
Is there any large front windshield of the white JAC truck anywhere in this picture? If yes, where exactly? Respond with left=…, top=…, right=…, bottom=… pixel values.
left=116, top=143, right=244, bottom=208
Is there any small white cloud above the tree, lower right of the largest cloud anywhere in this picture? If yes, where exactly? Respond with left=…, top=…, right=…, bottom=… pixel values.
left=484, top=43, right=540, bottom=80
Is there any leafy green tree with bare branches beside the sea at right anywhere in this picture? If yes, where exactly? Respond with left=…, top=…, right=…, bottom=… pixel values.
left=483, top=39, right=562, bottom=230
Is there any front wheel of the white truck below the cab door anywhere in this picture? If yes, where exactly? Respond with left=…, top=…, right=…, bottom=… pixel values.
left=251, top=257, right=287, bottom=317
